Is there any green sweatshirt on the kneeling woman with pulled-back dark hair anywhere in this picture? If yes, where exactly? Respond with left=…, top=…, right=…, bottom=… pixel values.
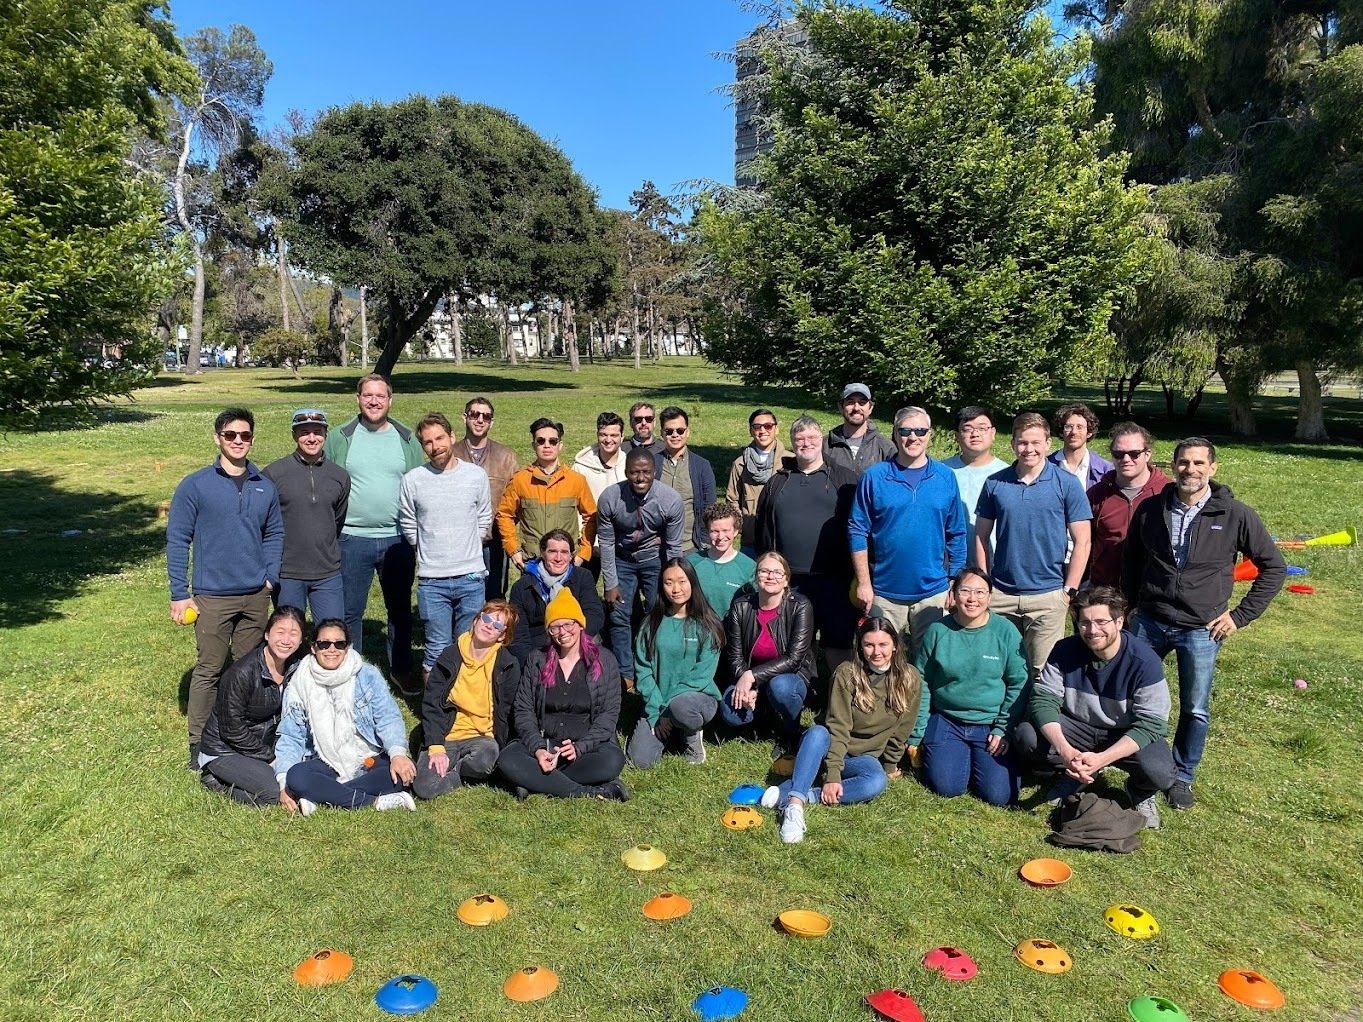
left=909, top=613, right=1028, bottom=745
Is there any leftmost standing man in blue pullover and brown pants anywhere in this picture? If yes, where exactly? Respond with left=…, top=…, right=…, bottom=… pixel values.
left=166, top=409, right=284, bottom=771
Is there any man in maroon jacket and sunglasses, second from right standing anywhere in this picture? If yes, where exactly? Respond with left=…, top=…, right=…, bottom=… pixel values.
left=1088, top=422, right=1169, bottom=587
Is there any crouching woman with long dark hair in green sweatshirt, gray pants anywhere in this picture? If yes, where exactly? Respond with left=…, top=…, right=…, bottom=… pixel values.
left=628, top=561, right=724, bottom=769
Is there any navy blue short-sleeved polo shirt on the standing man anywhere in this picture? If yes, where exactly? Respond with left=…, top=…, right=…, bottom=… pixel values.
left=975, top=462, right=1093, bottom=595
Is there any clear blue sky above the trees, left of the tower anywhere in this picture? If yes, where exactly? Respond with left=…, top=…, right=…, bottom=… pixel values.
left=170, top=0, right=756, bottom=208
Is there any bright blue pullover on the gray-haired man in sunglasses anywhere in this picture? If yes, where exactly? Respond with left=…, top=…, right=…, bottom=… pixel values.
left=848, top=458, right=966, bottom=602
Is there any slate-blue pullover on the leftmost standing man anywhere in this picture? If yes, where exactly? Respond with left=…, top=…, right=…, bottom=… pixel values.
left=166, top=459, right=284, bottom=600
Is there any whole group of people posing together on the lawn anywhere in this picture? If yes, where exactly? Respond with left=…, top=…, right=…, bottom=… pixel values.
left=166, top=376, right=1285, bottom=842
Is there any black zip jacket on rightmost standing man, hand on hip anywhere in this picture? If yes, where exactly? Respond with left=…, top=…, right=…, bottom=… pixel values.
left=1122, top=480, right=1287, bottom=628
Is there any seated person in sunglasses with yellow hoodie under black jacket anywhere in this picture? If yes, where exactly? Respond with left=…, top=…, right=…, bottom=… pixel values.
left=412, top=600, right=521, bottom=799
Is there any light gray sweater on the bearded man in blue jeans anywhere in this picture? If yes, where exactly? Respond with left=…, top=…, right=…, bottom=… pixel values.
left=398, top=461, right=492, bottom=578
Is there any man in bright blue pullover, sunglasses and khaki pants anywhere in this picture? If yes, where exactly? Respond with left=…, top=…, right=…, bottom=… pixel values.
left=848, top=407, right=968, bottom=660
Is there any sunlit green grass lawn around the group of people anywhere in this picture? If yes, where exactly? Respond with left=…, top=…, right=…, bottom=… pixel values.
left=0, top=360, right=1363, bottom=1022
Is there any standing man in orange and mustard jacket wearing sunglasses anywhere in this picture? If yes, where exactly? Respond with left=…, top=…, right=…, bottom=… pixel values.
left=496, top=418, right=596, bottom=571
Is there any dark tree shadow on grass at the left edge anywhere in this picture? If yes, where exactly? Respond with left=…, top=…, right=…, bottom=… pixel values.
left=0, top=469, right=165, bottom=628
